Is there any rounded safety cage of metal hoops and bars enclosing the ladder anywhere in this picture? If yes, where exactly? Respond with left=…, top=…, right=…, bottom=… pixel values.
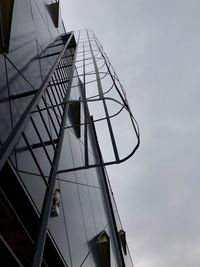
left=58, top=30, right=140, bottom=176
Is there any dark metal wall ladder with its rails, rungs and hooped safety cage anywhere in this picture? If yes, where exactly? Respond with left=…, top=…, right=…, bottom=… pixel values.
left=0, top=28, right=140, bottom=267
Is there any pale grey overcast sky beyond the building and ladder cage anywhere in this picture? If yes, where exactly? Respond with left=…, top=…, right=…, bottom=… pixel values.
left=62, top=0, right=200, bottom=267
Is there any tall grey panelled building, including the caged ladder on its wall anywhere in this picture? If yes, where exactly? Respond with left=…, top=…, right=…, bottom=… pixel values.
left=0, top=0, right=139, bottom=267
